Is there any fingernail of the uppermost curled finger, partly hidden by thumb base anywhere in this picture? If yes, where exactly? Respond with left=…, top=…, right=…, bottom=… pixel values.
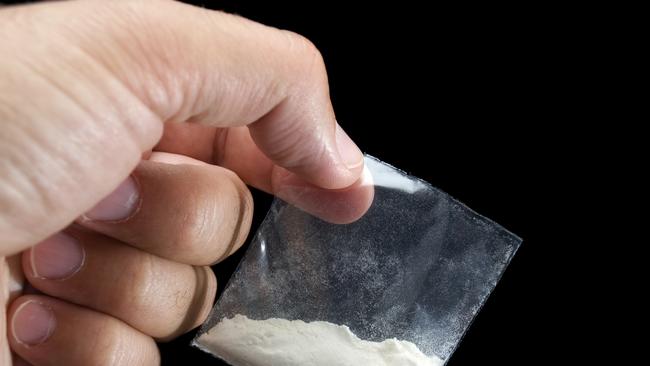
left=84, top=177, right=140, bottom=221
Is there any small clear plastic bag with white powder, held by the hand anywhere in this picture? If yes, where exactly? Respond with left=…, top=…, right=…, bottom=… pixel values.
left=193, top=156, right=521, bottom=366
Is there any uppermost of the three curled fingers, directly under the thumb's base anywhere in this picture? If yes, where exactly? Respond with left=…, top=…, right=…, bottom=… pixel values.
left=80, top=161, right=253, bottom=265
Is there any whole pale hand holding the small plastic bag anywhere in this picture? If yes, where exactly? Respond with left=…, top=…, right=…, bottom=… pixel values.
left=0, top=1, right=373, bottom=366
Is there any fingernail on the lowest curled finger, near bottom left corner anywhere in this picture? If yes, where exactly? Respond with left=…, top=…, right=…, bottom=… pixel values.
left=12, top=300, right=56, bottom=346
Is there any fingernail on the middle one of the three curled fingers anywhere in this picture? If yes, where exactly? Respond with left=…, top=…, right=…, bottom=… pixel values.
left=30, top=233, right=86, bottom=280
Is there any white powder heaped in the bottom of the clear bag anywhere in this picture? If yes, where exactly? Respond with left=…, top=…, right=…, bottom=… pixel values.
left=198, top=315, right=444, bottom=366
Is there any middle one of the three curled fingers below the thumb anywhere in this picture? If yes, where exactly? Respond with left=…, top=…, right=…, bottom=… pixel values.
left=23, top=230, right=217, bottom=339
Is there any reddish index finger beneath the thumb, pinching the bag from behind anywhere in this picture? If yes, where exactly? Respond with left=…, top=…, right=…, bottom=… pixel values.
left=153, top=126, right=374, bottom=224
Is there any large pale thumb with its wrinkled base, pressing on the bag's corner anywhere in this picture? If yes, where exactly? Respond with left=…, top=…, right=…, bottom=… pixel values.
left=0, top=1, right=363, bottom=253
